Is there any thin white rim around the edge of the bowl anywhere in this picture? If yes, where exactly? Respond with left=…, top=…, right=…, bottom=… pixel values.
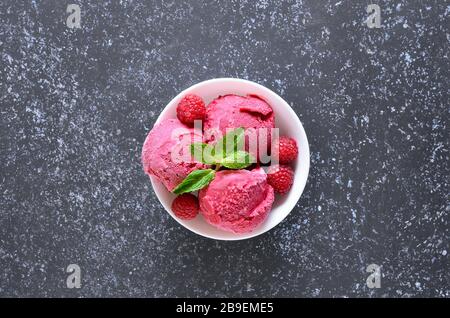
left=150, top=77, right=311, bottom=241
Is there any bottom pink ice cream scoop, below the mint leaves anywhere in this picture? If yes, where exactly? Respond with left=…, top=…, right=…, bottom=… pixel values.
left=199, top=168, right=274, bottom=233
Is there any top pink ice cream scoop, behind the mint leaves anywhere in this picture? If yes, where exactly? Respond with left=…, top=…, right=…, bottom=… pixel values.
left=204, top=95, right=275, bottom=158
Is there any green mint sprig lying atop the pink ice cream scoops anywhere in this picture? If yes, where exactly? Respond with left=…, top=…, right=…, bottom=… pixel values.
left=172, top=128, right=256, bottom=194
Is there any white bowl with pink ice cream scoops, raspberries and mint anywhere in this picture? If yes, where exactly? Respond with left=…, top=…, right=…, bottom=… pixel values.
left=142, top=78, right=309, bottom=240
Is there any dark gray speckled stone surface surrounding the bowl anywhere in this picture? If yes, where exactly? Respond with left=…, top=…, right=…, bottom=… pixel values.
left=0, top=0, right=450, bottom=297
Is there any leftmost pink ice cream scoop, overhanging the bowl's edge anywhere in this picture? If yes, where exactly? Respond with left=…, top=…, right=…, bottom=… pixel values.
left=142, top=119, right=205, bottom=191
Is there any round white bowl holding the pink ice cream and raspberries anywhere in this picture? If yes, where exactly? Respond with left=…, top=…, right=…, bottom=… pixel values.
left=151, top=78, right=309, bottom=241
